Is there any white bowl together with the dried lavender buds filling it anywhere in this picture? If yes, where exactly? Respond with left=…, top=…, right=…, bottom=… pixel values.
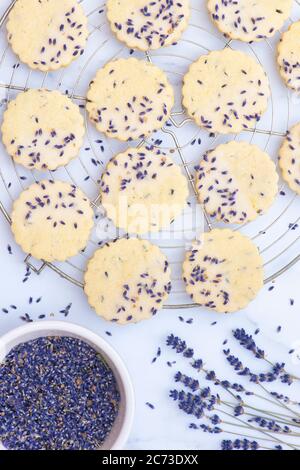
left=0, top=322, right=134, bottom=450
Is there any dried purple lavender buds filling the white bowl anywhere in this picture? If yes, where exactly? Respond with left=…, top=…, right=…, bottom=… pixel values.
left=0, top=337, right=120, bottom=450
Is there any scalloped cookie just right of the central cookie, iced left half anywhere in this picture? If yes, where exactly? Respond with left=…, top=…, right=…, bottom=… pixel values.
left=196, top=141, right=279, bottom=224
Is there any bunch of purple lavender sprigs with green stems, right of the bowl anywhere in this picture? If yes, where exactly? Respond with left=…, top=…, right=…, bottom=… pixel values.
left=166, top=329, right=300, bottom=450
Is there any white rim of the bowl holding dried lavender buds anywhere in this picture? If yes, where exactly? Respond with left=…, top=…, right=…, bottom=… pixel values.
left=0, top=321, right=135, bottom=450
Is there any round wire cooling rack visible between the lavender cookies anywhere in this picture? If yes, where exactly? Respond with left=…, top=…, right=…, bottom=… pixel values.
left=0, top=0, right=300, bottom=308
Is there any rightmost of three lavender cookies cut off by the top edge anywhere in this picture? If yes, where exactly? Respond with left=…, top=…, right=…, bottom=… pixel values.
left=207, top=0, right=293, bottom=42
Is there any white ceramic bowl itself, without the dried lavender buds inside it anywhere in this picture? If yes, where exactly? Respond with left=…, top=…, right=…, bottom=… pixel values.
left=0, top=321, right=134, bottom=450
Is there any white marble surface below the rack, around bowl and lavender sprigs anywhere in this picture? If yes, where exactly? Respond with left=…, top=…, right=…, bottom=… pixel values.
left=0, top=0, right=300, bottom=449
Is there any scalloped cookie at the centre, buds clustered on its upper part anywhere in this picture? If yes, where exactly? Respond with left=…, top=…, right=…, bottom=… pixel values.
left=101, top=147, right=189, bottom=234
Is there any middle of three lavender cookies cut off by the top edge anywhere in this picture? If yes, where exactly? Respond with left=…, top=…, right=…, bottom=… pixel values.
left=107, top=0, right=190, bottom=51
